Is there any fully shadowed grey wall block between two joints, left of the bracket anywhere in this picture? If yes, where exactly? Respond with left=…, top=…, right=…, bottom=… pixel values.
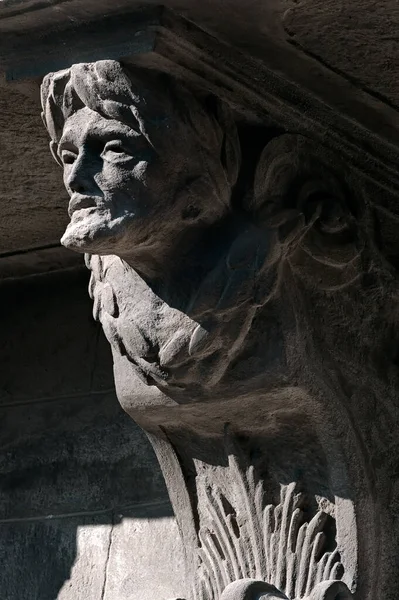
left=0, top=393, right=170, bottom=520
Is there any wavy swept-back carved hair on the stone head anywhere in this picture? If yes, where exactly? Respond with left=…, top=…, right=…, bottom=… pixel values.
left=41, top=60, right=241, bottom=203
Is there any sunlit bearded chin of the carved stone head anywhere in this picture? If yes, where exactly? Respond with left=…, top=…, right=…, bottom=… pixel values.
left=61, top=209, right=125, bottom=254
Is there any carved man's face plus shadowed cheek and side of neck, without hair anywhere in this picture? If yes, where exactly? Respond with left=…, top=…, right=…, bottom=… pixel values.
left=58, top=107, right=230, bottom=256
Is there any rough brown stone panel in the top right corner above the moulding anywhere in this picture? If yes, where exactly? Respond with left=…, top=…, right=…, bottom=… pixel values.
left=279, top=0, right=399, bottom=107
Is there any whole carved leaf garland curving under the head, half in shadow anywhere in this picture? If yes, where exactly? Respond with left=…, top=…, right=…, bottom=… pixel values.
left=87, top=230, right=277, bottom=396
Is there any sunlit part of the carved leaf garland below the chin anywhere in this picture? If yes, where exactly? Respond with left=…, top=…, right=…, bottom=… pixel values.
left=86, top=255, right=206, bottom=385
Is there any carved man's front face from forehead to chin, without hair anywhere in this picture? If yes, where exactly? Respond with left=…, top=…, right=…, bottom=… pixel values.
left=58, top=108, right=153, bottom=253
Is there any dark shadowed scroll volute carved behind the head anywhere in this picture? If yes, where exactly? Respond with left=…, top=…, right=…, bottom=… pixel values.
left=250, top=134, right=363, bottom=291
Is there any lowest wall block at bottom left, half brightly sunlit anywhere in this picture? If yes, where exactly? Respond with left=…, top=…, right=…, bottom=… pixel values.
left=0, top=506, right=184, bottom=600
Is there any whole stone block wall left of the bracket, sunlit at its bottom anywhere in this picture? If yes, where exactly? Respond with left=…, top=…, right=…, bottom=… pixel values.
left=0, top=269, right=182, bottom=600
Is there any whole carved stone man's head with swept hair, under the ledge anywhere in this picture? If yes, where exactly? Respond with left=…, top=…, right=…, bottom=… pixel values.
left=42, top=60, right=240, bottom=270
